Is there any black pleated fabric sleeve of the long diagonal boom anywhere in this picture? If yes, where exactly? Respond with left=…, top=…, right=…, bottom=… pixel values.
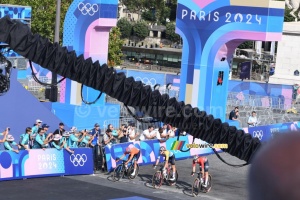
left=0, top=17, right=261, bottom=162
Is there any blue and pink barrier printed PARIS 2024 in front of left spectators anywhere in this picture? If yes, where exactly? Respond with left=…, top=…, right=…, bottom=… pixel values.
left=0, top=148, right=93, bottom=181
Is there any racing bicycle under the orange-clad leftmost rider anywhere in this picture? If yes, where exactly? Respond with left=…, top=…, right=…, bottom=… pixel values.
left=113, top=160, right=140, bottom=181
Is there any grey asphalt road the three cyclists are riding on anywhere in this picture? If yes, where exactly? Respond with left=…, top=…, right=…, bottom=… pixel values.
left=0, top=153, right=249, bottom=200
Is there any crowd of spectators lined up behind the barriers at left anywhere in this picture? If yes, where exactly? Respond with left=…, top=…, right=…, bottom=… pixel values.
left=0, top=119, right=183, bottom=171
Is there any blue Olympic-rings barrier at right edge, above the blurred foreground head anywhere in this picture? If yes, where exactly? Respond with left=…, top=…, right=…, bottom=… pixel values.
left=244, top=122, right=300, bottom=142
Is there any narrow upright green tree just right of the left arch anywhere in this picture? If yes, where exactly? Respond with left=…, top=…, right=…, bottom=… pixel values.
left=108, top=27, right=124, bottom=66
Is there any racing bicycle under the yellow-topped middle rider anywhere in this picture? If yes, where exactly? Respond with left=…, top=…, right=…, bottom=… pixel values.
left=152, top=163, right=178, bottom=189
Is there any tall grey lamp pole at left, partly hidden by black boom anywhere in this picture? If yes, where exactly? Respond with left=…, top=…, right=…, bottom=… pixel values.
left=49, top=0, right=61, bottom=102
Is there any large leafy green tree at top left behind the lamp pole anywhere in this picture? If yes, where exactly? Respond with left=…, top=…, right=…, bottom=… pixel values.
left=1, top=0, right=73, bottom=44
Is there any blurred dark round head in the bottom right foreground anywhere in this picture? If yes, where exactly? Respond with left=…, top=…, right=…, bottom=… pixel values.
left=248, top=132, right=300, bottom=200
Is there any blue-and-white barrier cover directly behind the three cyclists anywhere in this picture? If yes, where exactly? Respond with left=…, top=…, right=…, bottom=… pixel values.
left=105, top=135, right=220, bottom=171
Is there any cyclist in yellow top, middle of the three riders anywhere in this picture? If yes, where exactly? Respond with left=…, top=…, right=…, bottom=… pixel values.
left=154, top=147, right=176, bottom=181
